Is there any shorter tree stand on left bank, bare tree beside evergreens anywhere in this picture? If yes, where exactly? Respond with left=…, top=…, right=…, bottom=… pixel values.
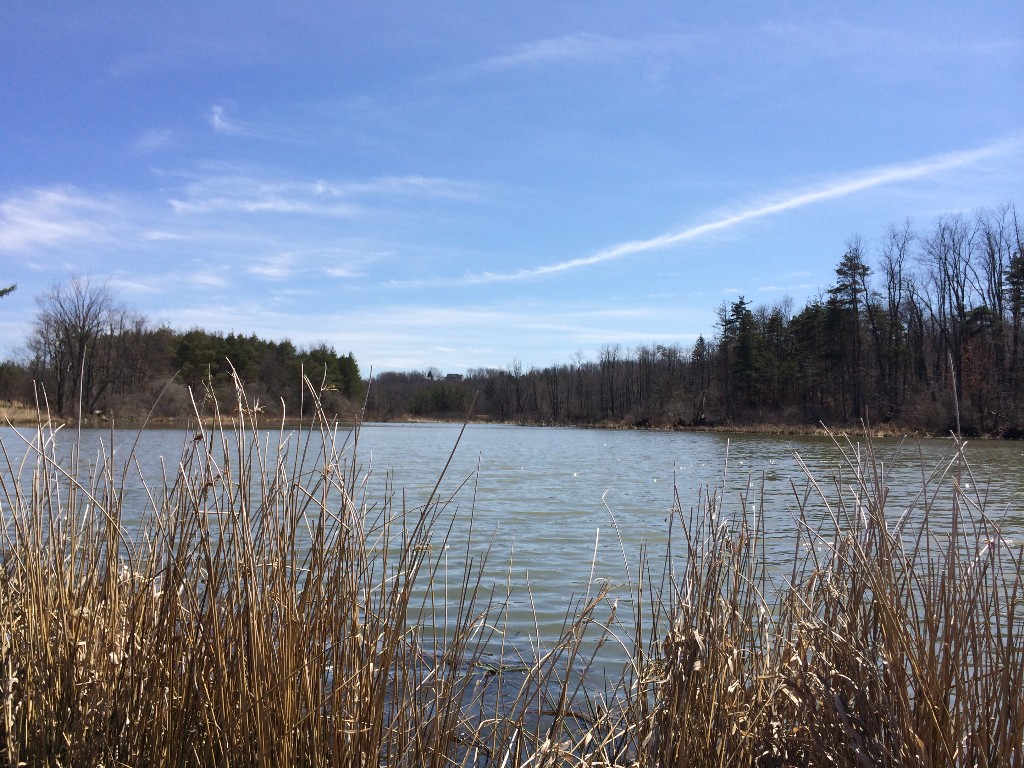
left=0, top=278, right=364, bottom=418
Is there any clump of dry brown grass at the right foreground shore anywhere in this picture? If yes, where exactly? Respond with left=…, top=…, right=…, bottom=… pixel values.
left=650, top=444, right=1024, bottom=766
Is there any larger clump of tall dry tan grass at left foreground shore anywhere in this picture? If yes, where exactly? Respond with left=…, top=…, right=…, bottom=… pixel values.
left=0, top=387, right=634, bottom=766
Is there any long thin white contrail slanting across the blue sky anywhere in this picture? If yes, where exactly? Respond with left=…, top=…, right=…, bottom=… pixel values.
left=466, top=136, right=1024, bottom=283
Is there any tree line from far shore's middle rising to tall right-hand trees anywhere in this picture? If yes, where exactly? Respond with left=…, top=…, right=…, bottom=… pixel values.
left=367, top=205, right=1024, bottom=436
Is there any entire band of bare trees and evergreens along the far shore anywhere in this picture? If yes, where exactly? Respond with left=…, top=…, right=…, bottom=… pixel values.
left=0, top=205, right=1024, bottom=436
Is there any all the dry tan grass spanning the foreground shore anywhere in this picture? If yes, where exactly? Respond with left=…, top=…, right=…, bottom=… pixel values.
left=0, top=382, right=1024, bottom=768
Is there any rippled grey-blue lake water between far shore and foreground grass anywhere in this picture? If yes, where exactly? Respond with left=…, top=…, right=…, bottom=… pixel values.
left=0, top=424, right=1024, bottom=647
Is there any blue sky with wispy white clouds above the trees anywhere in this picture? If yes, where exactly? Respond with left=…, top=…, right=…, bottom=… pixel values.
left=0, top=0, right=1024, bottom=376
